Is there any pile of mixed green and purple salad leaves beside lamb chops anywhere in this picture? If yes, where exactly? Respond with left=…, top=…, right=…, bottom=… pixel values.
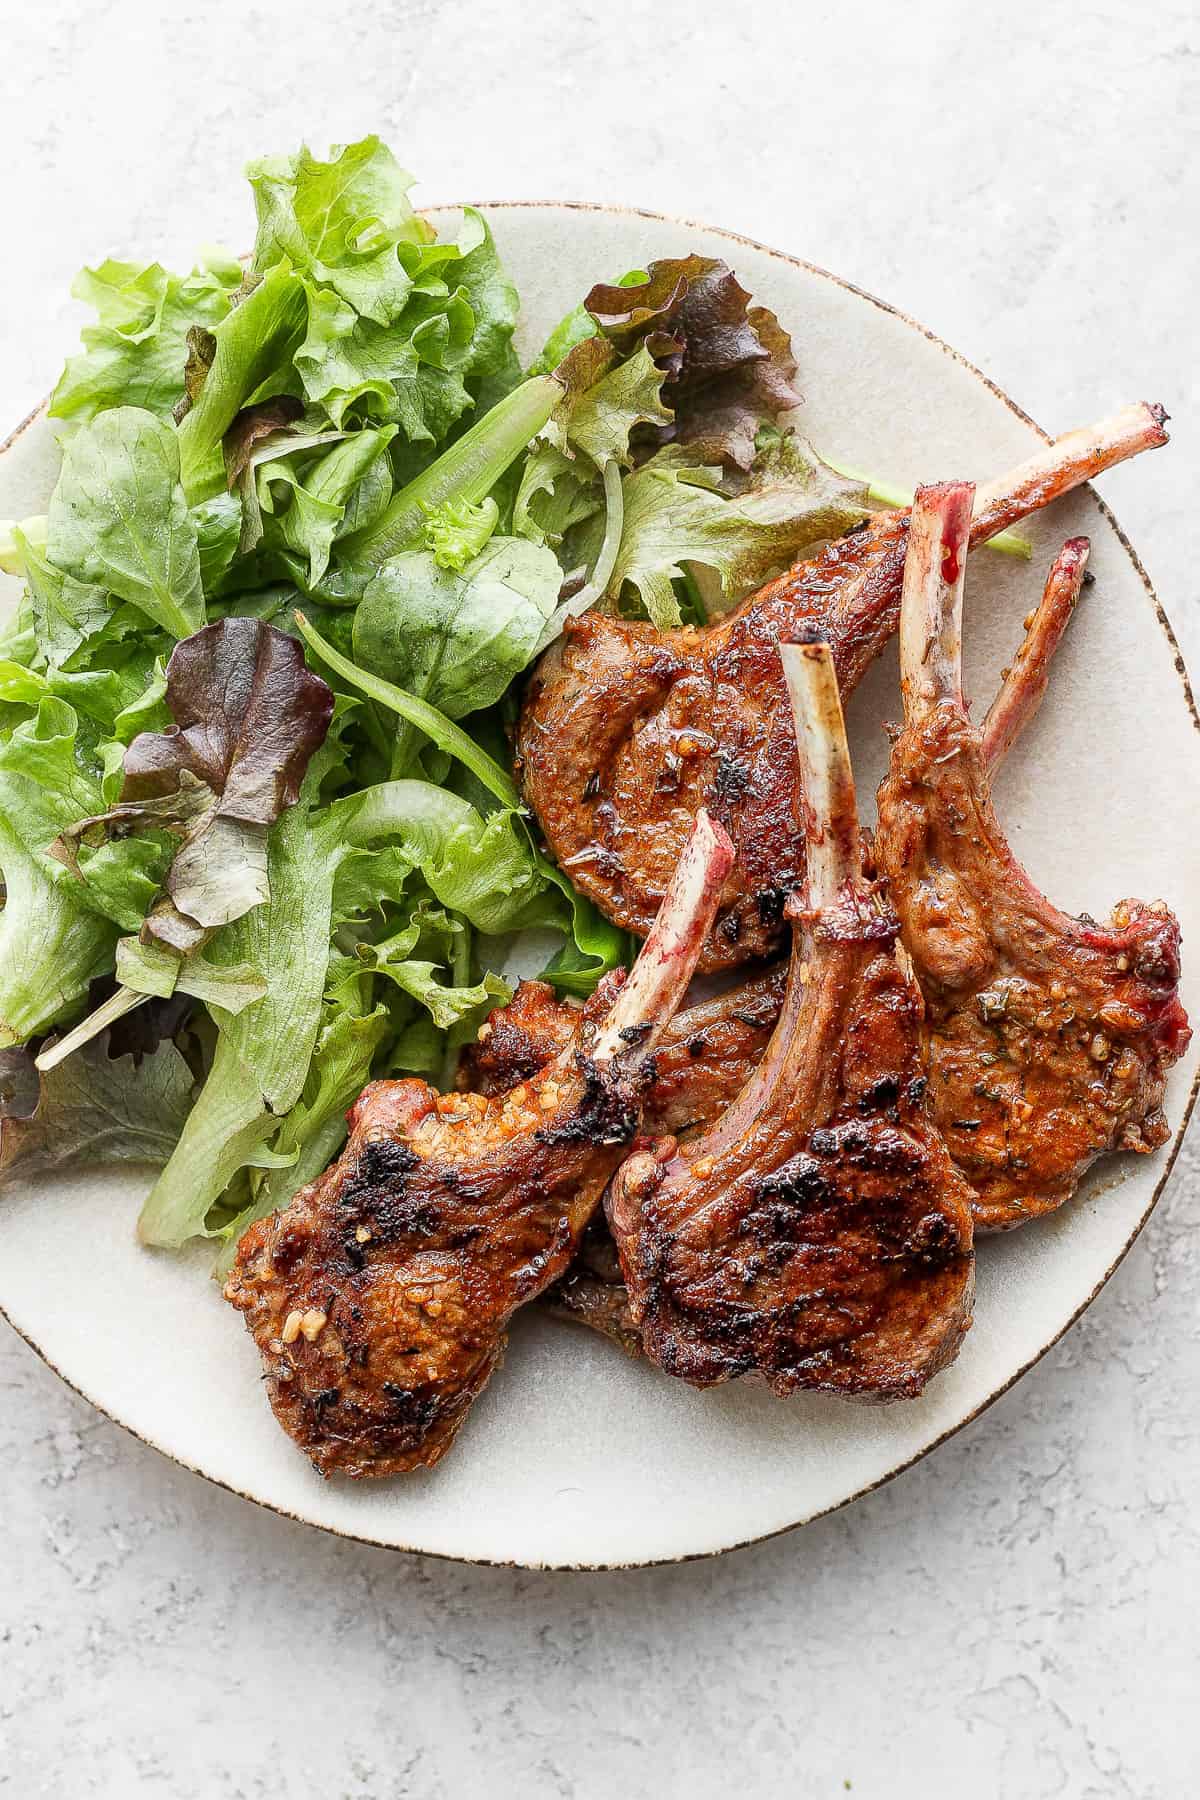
left=0, top=137, right=1021, bottom=1247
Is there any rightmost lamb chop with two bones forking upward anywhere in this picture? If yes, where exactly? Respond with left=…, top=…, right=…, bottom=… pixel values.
left=874, top=482, right=1191, bottom=1231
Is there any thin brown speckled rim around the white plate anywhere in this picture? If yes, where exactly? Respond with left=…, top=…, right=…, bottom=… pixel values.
left=0, top=200, right=1200, bottom=1575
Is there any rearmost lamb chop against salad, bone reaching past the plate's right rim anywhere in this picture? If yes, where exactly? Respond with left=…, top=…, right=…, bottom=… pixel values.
left=516, top=405, right=1166, bottom=970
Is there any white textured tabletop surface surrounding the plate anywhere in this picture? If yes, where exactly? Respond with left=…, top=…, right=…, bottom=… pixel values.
left=0, top=0, right=1200, bottom=1800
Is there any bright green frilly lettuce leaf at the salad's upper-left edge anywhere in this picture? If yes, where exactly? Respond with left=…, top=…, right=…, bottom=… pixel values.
left=50, top=257, right=243, bottom=423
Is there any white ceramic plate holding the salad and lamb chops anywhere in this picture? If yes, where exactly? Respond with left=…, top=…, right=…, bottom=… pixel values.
left=0, top=205, right=1200, bottom=1568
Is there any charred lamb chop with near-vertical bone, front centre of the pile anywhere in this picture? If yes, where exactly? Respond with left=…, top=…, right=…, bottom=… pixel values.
left=606, top=628, right=973, bottom=1399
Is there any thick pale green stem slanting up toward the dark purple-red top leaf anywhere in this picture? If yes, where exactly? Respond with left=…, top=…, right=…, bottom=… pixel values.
left=340, top=374, right=563, bottom=571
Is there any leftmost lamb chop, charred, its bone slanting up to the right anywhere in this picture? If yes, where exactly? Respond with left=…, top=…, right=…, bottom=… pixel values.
left=225, top=812, right=732, bottom=1476
